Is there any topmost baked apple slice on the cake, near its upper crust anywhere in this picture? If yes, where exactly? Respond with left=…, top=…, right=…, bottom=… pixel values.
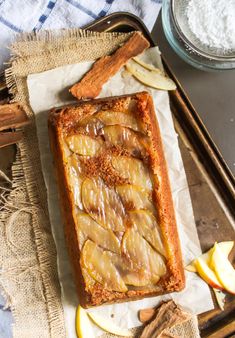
left=96, top=110, right=139, bottom=131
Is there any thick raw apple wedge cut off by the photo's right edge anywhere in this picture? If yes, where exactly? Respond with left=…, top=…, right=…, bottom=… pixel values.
left=210, top=243, right=235, bottom=295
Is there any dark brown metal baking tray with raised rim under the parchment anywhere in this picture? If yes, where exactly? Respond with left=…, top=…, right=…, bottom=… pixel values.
left=0, top=12, right=235, bottom=338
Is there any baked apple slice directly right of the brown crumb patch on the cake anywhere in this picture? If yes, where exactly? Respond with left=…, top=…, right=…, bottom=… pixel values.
left=111, top=156, right=152, bottom=190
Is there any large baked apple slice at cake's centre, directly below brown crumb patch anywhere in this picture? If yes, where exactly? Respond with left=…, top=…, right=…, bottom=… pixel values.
left=82, top=178, right=125, bottom=231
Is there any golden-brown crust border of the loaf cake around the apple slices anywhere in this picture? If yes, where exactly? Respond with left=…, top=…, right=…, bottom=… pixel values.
left=48, top=92, right=185, bottom=307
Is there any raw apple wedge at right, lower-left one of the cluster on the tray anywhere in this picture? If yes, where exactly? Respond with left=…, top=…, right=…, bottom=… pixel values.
left=194, top=257, right=223, bottom=290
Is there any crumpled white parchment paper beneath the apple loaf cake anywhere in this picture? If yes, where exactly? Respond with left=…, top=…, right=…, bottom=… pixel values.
left=27, top=47, right=213, bottom=338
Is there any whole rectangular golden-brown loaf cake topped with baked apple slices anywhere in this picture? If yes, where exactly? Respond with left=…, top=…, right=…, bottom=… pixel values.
left=49, top=92, right=185, bottom=307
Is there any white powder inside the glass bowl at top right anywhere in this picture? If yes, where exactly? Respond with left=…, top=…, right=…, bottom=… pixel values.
left=186, top=0, right=235, bottom=50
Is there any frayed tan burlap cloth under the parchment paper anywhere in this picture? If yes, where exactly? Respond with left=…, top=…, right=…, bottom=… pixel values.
left=0, top=29, right=199, bottom=338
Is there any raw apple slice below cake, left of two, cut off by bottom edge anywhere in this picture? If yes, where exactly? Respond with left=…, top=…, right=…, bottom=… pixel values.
left=75, top=305, right=95, bottom=338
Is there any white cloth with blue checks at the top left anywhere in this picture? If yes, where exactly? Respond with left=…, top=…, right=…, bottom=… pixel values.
left=0, top=0, right=161, bottom=71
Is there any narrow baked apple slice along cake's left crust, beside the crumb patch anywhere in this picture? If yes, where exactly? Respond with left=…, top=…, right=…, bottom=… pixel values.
left=67, top=154, right=83, bottom=209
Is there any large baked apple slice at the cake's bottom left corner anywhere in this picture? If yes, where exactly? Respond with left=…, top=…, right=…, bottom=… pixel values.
left=81, top=239, right=128, bottom=292
